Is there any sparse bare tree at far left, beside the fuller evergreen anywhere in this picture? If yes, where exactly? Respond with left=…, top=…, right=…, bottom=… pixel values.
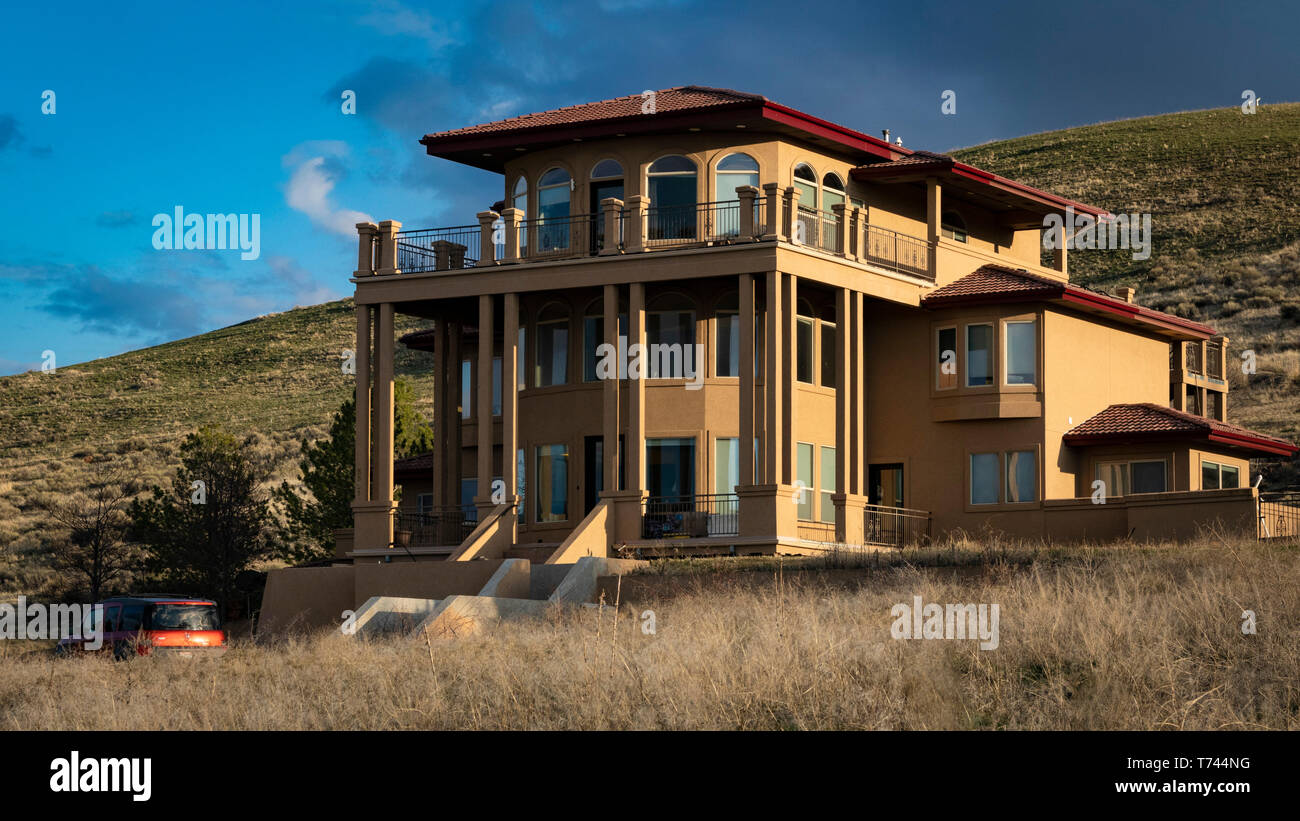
left=46, top=462, right=139, bottom=601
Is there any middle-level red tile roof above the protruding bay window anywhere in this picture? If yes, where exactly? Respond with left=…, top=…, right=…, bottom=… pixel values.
left=920, top=265, right=1216, bottom=339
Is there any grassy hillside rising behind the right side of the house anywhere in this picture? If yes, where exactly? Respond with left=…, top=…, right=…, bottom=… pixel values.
left=954, top=104, right=1300, bottom=438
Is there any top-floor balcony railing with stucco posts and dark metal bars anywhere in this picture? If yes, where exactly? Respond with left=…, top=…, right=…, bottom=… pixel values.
left=355, top=184, right=933, bottom=282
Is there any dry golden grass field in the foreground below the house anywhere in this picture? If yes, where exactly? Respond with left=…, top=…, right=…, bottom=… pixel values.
left=0, top=540, right=1300, bottom=730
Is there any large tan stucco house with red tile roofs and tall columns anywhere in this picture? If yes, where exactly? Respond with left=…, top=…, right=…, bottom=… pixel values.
left=341, top=87, right=1296, bottom=562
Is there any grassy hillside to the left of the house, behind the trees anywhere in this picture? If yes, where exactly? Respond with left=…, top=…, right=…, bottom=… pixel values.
left=0, top=299, right=432, bottom=594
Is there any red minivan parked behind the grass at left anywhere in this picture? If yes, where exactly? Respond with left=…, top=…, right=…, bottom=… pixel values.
left=55, top=596, right=226, bottom=659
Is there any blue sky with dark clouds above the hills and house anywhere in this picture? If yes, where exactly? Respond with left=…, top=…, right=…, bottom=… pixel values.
left=0, top=0, right=1300, bottom=374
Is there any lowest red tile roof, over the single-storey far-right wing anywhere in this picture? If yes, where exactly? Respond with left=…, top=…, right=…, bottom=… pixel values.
left=1065, top=403, right=1300, bottom=456
